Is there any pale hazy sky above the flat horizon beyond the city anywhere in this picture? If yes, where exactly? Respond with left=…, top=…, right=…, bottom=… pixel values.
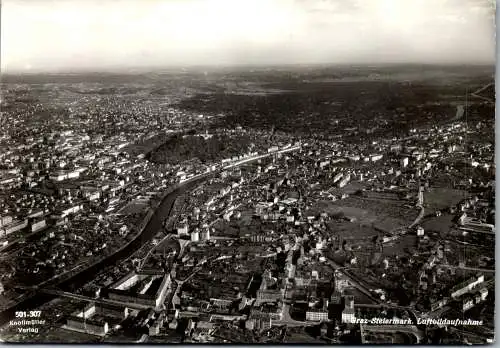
left=0, top=0, right=495, bottom=72
